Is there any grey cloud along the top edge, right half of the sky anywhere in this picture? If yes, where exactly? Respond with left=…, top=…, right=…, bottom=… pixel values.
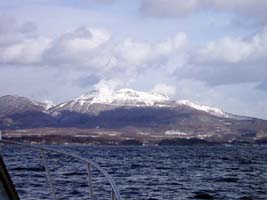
left=140, top=0, right=267, bottom=23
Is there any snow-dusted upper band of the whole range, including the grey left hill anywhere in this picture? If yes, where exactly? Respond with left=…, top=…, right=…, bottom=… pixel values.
left=0, top=89, right=251, bottom=120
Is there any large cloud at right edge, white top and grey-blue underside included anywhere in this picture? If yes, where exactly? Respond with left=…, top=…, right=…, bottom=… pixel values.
left=179, top=29, right=267, bottom=85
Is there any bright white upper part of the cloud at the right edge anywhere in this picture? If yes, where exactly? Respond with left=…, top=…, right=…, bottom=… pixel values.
left=196, top=29, right=267, bottom=64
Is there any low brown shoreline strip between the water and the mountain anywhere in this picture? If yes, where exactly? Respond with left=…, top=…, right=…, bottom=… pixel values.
left=2, top=128, right=267, bottom=146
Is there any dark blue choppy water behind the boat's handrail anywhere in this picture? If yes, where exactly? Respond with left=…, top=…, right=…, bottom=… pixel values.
left=0, top=145, right=267, bottom=200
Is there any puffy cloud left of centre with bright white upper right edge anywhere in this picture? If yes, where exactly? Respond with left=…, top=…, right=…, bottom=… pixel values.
left=44, top=27, right=110, bottom=68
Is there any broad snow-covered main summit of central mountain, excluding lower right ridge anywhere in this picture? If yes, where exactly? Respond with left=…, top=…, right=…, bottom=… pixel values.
left=49, top=89, right=173, bottom=114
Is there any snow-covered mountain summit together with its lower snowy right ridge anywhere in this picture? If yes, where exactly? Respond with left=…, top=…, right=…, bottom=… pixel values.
left=50, top=89, right=238, bottom=118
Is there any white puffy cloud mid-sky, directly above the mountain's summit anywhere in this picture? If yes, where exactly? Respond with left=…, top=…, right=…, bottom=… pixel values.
left=114, top=32, right=188, bottom=73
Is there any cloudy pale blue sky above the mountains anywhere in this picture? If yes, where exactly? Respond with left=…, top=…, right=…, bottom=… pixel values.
left=0, top=0, right=267, bottom=119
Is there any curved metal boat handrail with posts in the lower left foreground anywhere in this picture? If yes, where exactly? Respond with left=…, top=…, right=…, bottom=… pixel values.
left=0, top=139, right=122, bottom=200
